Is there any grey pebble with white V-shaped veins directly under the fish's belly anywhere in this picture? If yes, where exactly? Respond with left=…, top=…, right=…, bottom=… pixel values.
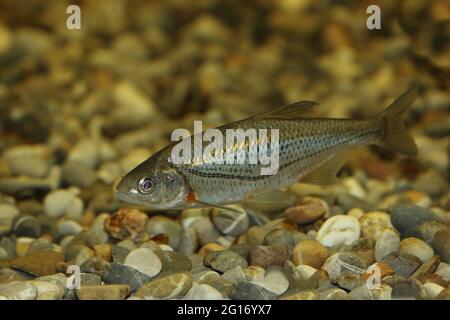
left=210, top=205, right=250, bottom=236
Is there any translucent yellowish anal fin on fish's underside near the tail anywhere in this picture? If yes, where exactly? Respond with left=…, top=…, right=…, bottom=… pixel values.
left=300, top=152, right=348, bottom=185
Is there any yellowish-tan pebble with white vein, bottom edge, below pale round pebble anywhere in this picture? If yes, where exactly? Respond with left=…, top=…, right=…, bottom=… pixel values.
left=136, top=272, right=192, bottom=299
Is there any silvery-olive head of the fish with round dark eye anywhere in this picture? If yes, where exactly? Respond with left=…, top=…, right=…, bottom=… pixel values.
left=116, top=157, right=188, bottom=210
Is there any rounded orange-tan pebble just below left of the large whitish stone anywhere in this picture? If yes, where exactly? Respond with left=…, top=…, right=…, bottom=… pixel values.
left=292, top=240, right=329, bottom=269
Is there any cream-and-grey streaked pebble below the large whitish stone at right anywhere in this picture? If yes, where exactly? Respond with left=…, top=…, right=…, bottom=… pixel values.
left=322, top=252, right=366, bottom=282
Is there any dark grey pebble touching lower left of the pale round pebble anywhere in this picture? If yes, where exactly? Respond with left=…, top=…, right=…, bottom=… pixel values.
left=102, top=262, right=152, bottom=292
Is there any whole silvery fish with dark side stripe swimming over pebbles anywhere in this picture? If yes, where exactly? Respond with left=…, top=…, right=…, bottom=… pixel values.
left=116, top=86, right=418, bottom=210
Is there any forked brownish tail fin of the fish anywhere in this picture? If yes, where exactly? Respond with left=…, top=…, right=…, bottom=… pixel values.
left=379, top=86, right=418, bottom=156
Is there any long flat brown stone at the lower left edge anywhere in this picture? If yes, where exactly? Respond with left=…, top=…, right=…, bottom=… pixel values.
left=0, top=251, right=64, bottom=276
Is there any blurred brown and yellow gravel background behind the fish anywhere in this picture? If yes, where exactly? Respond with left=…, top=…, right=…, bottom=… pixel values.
left=0, top=0, right=450, bottom=211
